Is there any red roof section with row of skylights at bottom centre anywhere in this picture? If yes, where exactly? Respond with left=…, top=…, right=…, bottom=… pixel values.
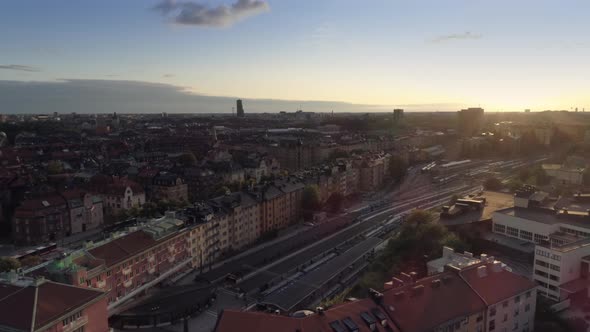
left=215, top=299, right=399, bottom=332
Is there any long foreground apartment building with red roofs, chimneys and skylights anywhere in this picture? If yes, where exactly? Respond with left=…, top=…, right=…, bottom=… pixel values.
left=215, top=255, right=536, bottom=332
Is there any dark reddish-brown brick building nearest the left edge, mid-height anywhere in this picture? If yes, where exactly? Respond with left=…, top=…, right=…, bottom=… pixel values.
left=12, top=194, right=71, bottom=245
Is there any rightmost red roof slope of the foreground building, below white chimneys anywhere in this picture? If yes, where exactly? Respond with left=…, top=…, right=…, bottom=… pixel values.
left=459, top=263, right=536, bottom=305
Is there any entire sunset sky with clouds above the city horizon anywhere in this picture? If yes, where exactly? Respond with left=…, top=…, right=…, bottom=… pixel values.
left=0, top=0, right=590, bottom=113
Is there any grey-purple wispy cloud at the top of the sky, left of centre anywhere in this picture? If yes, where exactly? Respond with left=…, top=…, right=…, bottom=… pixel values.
left=153, top=0, right=270, bottom=28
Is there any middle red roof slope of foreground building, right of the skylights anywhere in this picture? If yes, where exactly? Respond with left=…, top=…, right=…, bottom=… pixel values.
left=383, top=272, right=486, bottom=332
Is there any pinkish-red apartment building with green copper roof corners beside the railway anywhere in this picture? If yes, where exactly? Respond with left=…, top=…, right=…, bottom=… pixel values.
left=44, top=214, right=191, bottom=310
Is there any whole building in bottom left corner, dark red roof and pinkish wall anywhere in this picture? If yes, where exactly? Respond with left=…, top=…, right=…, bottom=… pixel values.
left=0, top=275, right=110, bottom=332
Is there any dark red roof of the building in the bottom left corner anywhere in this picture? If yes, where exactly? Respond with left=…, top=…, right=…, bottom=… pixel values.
left=0, top=281, right=106, bottom=331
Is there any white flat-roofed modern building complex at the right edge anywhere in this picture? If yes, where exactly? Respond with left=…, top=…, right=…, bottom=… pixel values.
left=492, top=187, right=590, bottom=301
